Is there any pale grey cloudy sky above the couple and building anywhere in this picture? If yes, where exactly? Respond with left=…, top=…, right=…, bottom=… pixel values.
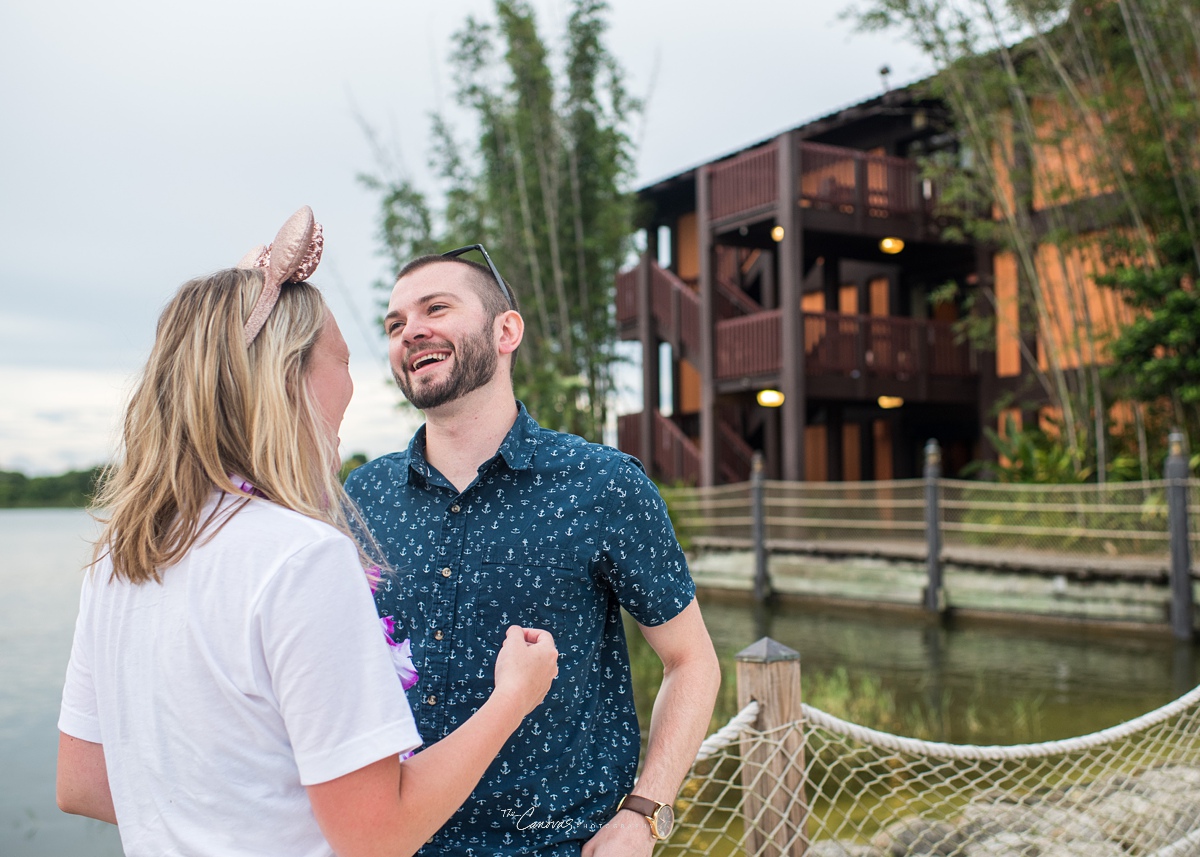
left=0, top=0, right=929, bottom=473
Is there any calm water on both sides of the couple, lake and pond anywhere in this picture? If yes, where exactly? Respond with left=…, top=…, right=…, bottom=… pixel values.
left=0, top=510, right=1200, bottom=857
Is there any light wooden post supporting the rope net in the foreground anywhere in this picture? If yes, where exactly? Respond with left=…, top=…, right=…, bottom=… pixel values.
left=737, top=637, right=809, bottom=857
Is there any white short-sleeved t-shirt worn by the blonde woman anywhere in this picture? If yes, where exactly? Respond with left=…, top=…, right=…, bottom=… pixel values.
left=59, top=493, right=421, bottom=857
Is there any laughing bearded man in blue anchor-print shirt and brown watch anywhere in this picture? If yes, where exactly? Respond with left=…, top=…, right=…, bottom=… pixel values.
left=347, top=245, right=720, bottom=857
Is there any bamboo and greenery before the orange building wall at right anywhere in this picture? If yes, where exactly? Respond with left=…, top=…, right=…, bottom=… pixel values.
left=854, top=0, right=1200, bottom=481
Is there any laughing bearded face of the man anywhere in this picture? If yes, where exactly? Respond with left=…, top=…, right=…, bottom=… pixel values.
left=384, top=263, right=498, bottom=410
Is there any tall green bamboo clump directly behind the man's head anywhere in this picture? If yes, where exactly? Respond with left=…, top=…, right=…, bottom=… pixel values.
left=368, top=0, right=640, bottom=441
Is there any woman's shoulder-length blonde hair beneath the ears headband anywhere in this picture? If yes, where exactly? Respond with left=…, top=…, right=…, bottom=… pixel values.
left=92, top=269, right=360, bottom=583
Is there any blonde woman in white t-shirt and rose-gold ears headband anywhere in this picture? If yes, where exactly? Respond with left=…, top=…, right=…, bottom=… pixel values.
left=58, top=209, right=557, bottom=857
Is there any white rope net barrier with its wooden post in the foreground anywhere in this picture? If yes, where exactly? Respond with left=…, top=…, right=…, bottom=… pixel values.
left=672, top=688, right=1200, bottom=857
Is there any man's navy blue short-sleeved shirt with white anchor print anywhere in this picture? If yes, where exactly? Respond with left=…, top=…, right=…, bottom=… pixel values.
left=346, top=403, right=696, bottom=857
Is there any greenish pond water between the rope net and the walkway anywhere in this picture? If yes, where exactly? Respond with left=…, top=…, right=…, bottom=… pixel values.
left=630, top=593, right=1200, bottom=744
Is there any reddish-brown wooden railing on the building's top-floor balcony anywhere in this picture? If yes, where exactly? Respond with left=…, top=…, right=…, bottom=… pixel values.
left=709, top=140, right=932, bottom=221
